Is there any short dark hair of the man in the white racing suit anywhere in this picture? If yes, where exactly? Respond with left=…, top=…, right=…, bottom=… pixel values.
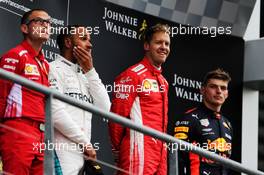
left=57, top=24, right=85, bottom=51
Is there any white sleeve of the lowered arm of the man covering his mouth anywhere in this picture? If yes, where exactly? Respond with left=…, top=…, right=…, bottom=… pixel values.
left=49, top=66, right=90, bottom=145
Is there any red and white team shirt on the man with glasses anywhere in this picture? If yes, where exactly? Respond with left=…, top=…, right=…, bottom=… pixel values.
left=0, top=41, right=49, bottom=122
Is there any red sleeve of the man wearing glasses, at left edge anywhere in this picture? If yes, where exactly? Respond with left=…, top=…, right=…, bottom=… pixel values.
left=0, top=52, right=24, bottom=118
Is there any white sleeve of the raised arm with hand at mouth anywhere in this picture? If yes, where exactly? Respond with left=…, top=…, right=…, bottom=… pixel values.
left=85, top=68, right=111, bottom=111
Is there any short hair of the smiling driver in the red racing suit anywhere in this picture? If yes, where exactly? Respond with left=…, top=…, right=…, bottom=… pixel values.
left=143, top=23, right=170, bottom=43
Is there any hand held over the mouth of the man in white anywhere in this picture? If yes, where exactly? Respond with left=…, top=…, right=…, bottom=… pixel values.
left=73, top=46, right=93, bottom=73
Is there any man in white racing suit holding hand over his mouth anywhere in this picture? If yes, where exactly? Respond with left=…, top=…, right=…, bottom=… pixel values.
left=49, top=25, right=110, bottom=175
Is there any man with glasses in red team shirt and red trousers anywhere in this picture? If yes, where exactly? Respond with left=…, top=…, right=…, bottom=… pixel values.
left=0, top=9, right=50, bottom=175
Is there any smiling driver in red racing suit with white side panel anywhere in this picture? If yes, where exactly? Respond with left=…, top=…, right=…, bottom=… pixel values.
left=109, top=24, right=170, bottom=175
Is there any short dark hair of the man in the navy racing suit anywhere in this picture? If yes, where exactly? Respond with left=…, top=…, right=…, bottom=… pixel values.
left=202, top=68, right=231, bottom=86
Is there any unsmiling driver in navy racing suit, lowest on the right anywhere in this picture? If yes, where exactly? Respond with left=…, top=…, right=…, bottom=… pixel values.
left=174, top=69, right=232, bottom=175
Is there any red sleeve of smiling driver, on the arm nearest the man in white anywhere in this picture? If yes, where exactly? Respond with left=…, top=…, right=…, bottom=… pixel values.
left=109, top=71, right=137, bottom=150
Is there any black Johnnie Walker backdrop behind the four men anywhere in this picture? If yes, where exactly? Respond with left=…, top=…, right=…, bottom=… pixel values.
left=0, top=0, right=244, bottom=174
